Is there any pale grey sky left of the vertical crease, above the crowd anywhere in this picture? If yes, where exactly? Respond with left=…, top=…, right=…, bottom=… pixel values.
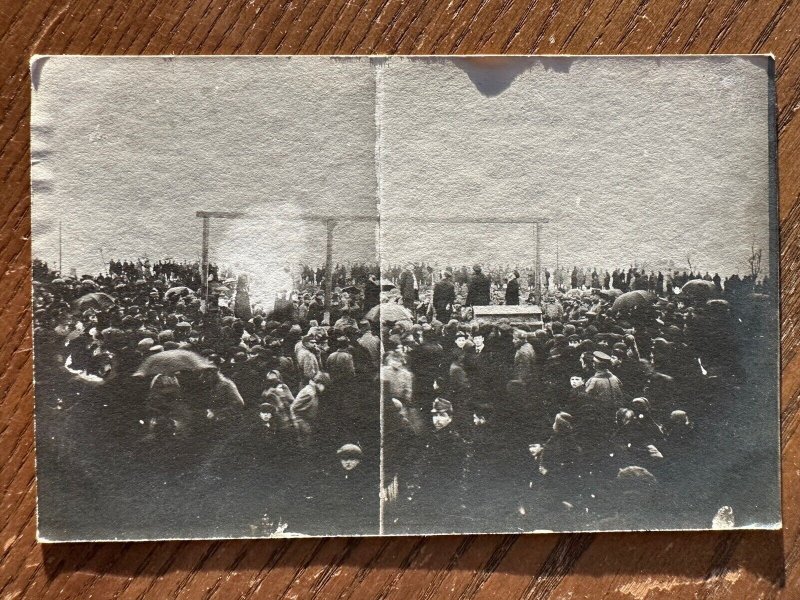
left=32, top=56, right=377, bottom=273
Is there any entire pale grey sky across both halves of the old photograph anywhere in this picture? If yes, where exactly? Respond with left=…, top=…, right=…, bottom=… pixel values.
left=32, top=57, right=770, bottom=274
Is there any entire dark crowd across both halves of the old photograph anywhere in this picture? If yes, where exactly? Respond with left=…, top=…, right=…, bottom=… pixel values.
left=33, top=255, right=775, bottom=537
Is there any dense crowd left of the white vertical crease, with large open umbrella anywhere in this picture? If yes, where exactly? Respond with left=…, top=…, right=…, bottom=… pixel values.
left=34, top=261, right=380, bottom=535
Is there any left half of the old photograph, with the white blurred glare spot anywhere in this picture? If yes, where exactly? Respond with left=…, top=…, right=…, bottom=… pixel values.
left=32, top=57, right=380, bottom=540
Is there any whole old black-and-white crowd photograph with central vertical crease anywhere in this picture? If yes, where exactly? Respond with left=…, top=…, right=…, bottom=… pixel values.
left=31, top=55, right=781, bottom=542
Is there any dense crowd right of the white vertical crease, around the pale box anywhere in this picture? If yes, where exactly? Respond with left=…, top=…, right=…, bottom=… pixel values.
left=382, top=265, right=776, bottom=531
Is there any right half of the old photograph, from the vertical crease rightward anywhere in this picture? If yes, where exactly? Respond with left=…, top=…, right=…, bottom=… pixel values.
left=378, top=57, right=780, bottom=533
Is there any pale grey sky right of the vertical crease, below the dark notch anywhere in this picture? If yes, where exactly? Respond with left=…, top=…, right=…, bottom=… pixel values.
left=381, top=57, right=770, bottom=273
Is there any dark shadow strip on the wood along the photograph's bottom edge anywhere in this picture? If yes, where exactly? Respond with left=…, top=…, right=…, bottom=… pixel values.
left=41, top=530, right=785, bottom=590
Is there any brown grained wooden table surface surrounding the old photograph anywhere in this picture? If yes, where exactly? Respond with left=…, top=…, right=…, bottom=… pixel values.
left=0, top=0, right=800, bottom=600
